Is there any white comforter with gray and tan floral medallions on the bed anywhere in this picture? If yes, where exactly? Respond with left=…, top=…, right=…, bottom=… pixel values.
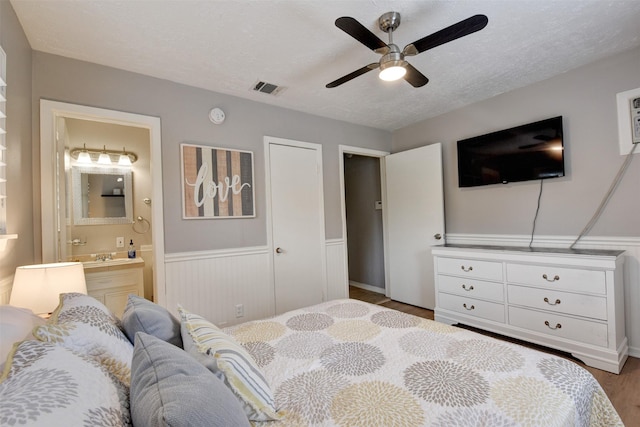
left=225, top=300, right=622, bottom=427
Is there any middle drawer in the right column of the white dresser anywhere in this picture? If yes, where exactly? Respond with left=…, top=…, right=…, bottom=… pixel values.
left=507, top=285, right=607, bottom=320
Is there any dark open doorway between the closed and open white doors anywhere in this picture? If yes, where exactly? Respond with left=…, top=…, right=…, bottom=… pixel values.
left=340, top=146, right=388, bottom=304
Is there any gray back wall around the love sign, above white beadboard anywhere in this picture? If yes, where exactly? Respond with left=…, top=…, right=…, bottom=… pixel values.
left=33, top=52, right=391, bottom=253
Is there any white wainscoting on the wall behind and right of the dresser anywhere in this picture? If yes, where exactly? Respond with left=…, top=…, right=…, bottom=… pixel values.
left=446, top=234, right=640, bottom=357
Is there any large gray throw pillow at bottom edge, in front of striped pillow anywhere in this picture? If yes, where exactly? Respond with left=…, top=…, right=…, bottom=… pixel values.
left=131, top=332, right=250, bottom=427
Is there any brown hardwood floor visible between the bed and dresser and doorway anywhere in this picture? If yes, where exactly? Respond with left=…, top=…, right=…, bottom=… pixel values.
left=349, top=286, right=640, bottom=427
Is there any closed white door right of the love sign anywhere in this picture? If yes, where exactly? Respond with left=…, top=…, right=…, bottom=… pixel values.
left=265, top=138, right=326, bottom=313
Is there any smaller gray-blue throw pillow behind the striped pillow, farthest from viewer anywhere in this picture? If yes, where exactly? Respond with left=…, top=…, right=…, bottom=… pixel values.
left=122, top=295, right=182, bottom=348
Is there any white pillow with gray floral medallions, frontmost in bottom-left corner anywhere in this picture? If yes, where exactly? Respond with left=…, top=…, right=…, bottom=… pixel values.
left=0, top=340, right=131, bottom=427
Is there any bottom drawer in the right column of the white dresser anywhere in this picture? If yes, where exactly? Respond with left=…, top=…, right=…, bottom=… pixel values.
left=509, top=307, right=608, bottom=347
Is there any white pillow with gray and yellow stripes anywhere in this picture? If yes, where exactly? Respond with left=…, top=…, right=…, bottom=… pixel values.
left=178, top=306, right=280, bottom=421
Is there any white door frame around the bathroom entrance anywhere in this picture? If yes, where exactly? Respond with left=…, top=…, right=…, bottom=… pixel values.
left=40, top=99, right=166, bottom=306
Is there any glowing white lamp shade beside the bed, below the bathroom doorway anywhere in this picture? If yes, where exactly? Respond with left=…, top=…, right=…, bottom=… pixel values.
left=9, top=262, right=87, bottom=314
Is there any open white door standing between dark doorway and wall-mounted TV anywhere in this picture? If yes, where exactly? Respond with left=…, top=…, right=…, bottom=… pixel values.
left=384, top=144, right=444, bottom=309
